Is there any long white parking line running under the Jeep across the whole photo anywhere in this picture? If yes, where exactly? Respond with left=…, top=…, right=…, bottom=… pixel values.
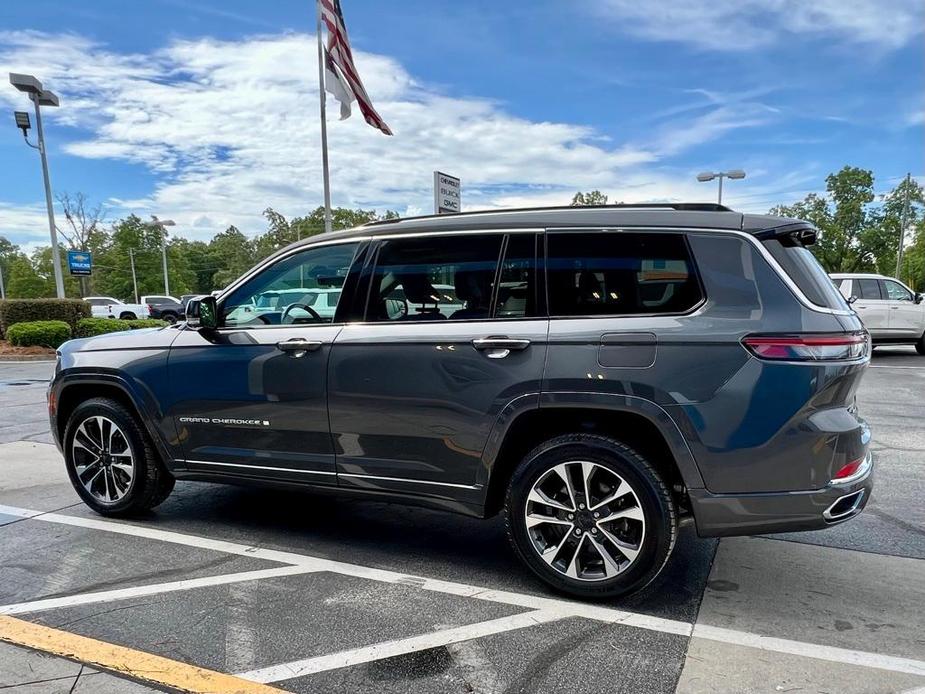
left=0, top=505, right=925, bottom=675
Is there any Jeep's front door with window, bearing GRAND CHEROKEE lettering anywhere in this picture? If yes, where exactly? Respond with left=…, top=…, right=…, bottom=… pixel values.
left=168, top=243, right=358, bottom=484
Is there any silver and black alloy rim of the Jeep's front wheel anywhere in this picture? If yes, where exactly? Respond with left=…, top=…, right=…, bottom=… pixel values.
left=71, top=415, right=135, bottom=504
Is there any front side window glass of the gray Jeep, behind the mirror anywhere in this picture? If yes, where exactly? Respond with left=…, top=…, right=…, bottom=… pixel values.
left=221, top=243, right=359, bottom=328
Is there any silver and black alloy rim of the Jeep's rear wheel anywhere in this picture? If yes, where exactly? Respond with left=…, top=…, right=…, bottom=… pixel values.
left=524, top=460, right=646, bottom=581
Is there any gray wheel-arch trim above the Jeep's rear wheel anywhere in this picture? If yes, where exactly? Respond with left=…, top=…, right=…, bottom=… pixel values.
left=478, top=391, right=704, bottom=489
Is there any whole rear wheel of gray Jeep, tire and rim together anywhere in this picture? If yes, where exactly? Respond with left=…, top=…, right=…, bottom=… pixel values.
left=505, top=434, right=678, bottom=598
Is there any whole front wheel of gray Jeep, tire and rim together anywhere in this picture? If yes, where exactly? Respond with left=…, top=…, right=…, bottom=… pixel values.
left=64, top=398, right=174, bottom=516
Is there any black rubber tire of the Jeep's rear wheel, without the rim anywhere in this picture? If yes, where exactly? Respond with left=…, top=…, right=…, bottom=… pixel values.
left=504, top=434, right=678, bottom=599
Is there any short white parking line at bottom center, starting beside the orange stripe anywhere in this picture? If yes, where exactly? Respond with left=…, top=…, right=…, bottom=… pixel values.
left=236, top=610, right=572, bottom=684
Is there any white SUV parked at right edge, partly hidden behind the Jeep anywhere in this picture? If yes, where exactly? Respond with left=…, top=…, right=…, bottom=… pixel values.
left=831, top=273, right=925, bottom=354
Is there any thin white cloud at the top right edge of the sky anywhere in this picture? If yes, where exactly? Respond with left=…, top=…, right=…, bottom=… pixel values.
left=595, top=0, right=925, bottom=51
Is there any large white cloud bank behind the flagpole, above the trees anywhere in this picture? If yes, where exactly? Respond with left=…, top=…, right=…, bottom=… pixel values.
left=0, top=32, right=775, bottom=245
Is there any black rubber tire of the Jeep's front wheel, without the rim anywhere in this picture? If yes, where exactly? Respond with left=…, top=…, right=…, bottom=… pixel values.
left=64, top=398, right=175, bottom=517
